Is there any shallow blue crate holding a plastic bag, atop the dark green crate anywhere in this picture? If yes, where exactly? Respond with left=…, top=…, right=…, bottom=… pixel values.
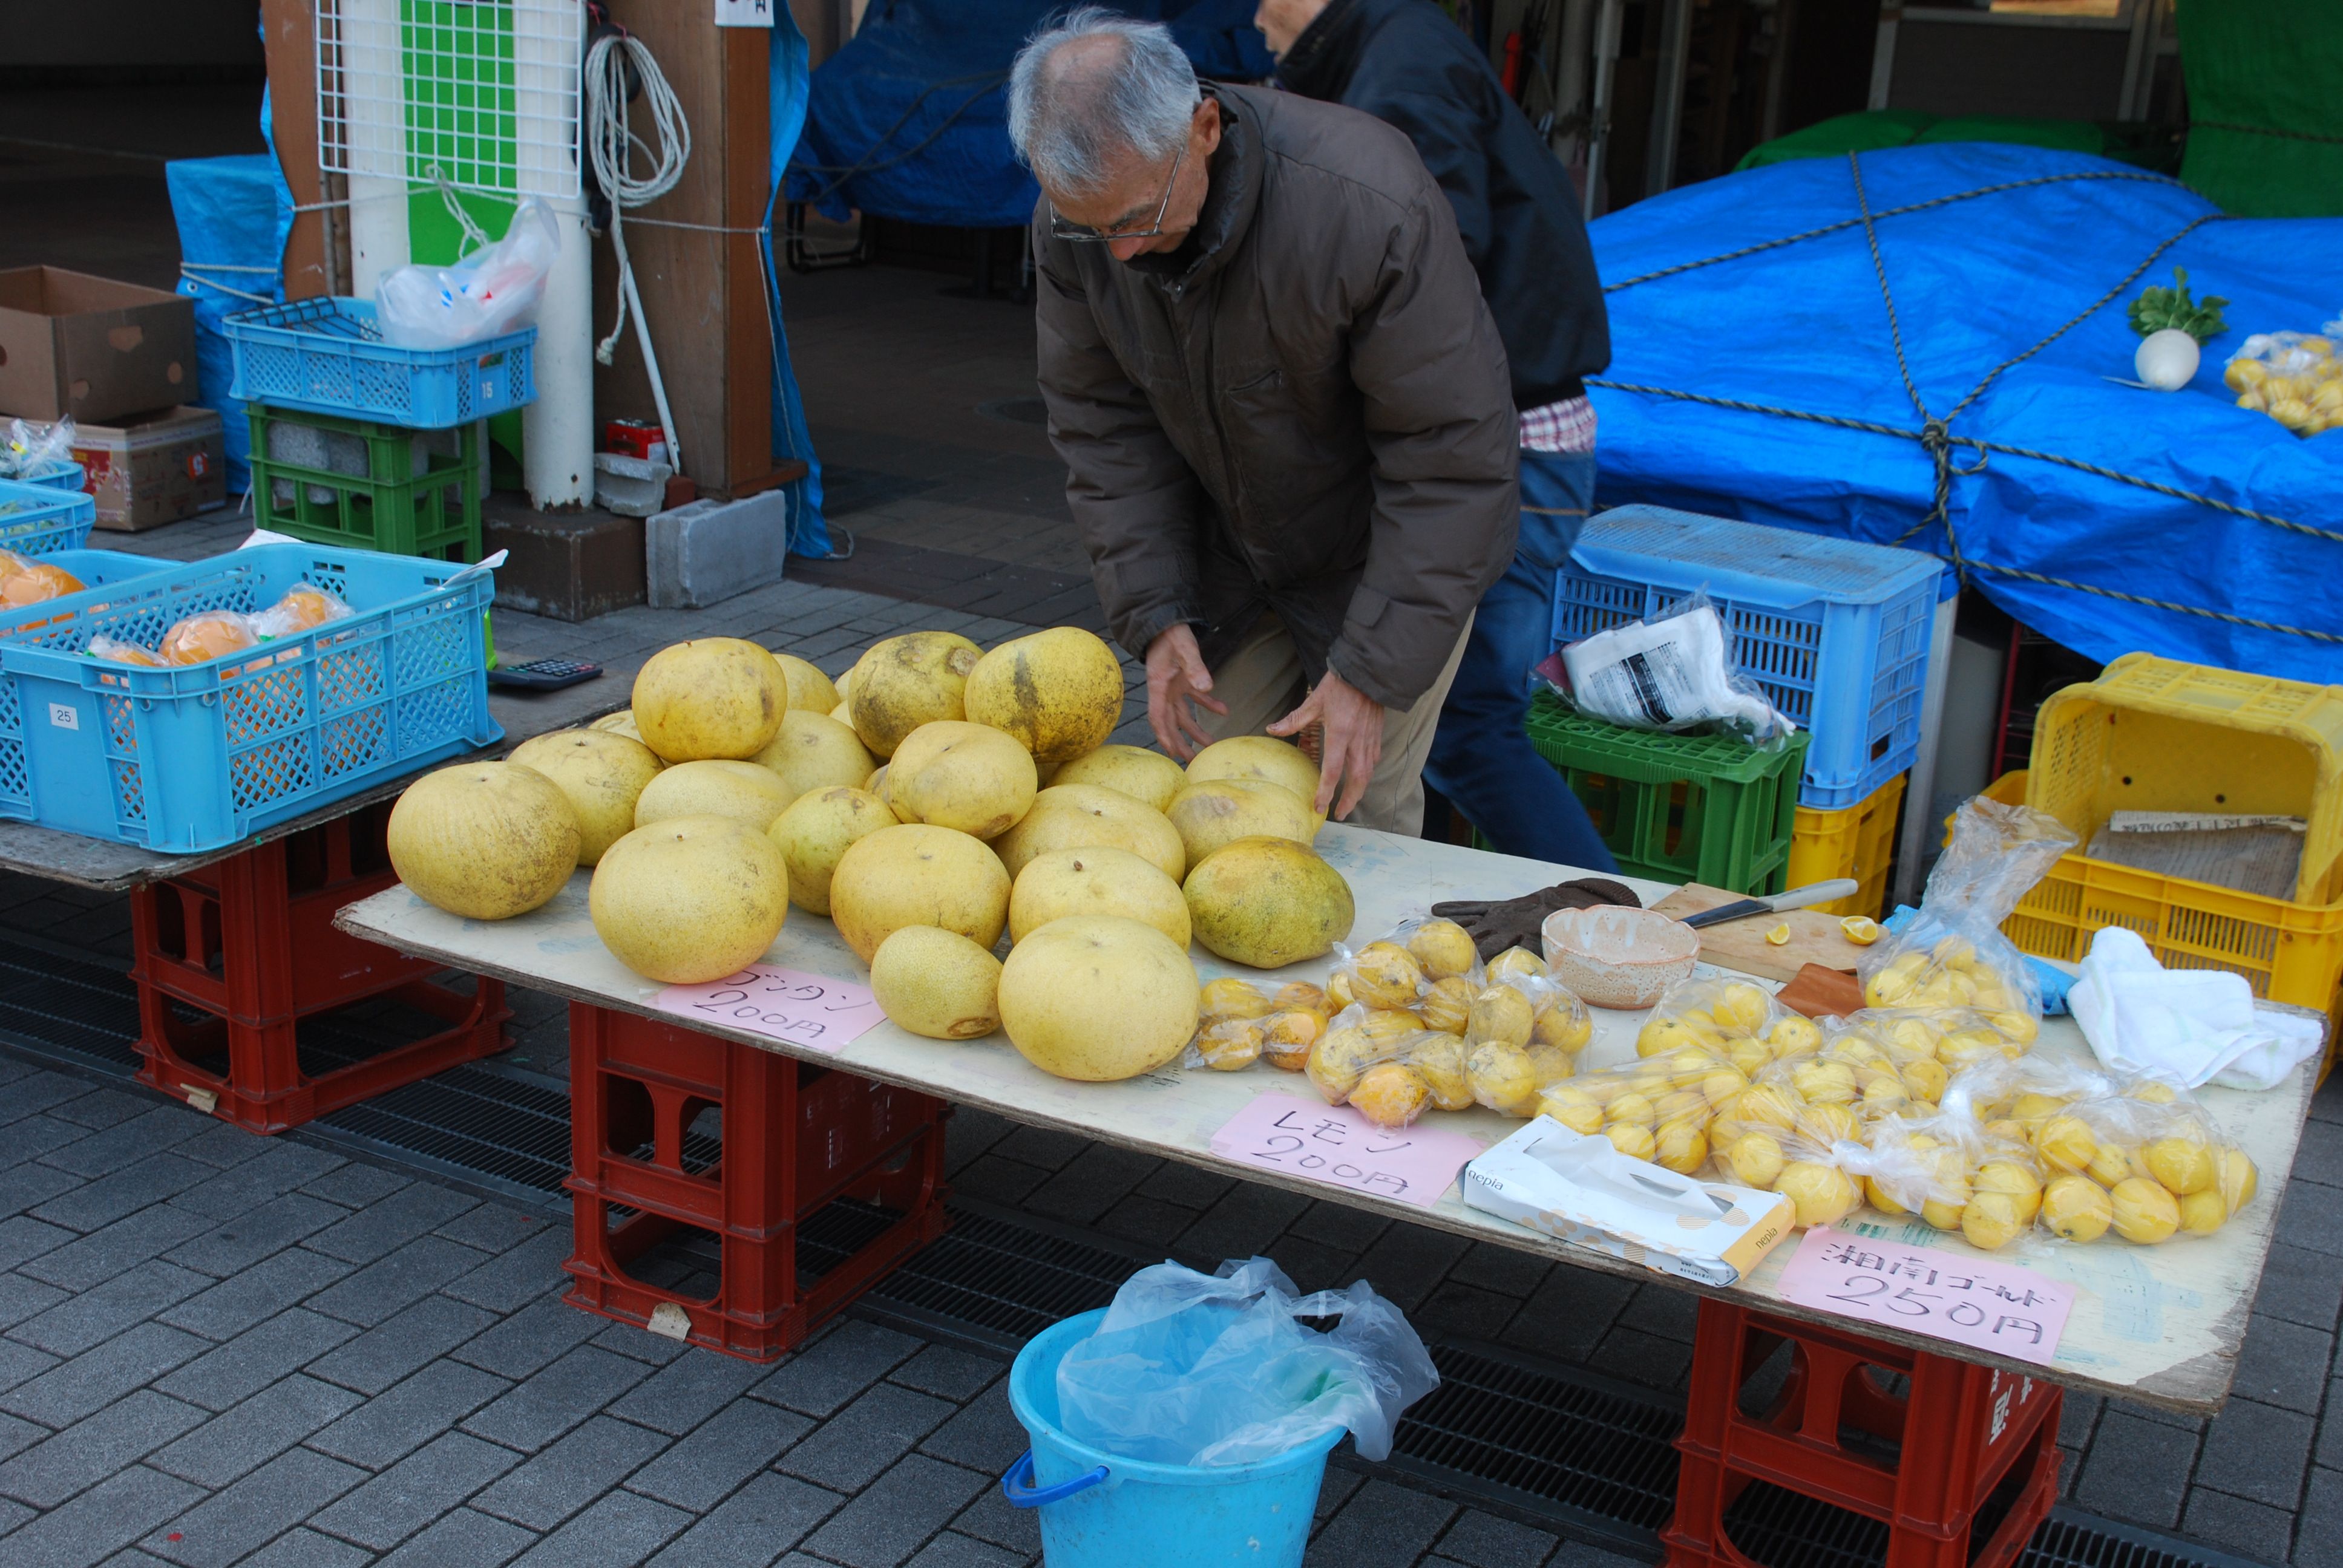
left=220, top=298, right=537, bottom=431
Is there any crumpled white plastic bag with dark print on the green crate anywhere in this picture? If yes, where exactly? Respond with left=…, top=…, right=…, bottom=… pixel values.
left=1561, top=593, right=1797, bottom=740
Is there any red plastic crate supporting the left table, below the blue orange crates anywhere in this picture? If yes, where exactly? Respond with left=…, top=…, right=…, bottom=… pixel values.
left=131, top=802, right=511, bottom=1132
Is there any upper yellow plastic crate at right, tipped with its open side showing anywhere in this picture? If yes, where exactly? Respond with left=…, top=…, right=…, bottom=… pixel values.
left=2024, top=654, right=2343, bottom=905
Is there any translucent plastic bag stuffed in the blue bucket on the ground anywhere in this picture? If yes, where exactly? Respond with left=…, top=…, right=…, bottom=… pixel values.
left=1057, top=1259, right=1441, bottom=1465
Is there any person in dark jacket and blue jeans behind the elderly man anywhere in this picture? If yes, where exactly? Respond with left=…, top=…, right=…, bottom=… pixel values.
left=1254, top=0, right=1617, bottom=872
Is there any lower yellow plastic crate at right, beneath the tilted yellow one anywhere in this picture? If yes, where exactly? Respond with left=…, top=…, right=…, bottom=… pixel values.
left=1985, top=774, right=2343, bottom=1050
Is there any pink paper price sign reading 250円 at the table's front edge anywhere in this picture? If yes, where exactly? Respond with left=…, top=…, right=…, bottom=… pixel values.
left=1781, top=1226, right=2074, bottom=1367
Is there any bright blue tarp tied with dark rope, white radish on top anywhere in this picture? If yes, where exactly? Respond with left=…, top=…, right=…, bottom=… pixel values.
left=1593, top=143, right=2343, bottom=682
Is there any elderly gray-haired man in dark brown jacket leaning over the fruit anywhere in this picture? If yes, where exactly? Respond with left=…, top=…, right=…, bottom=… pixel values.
left=1010, top=9, right=1518, bottom=834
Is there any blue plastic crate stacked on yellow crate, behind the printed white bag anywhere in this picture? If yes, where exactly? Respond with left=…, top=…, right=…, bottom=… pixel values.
left=1553, top=506, right=1956, bottom=811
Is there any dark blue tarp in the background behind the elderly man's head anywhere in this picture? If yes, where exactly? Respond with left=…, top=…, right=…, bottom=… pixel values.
left=787, top=0, right=1274, bottom=227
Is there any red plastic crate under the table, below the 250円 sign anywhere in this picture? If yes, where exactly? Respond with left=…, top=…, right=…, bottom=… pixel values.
left=1661, top=1298, right=2064, bottom=1568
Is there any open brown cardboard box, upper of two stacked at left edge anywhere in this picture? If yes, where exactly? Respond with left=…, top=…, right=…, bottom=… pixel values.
left=0, top=267, right=199, bottom=422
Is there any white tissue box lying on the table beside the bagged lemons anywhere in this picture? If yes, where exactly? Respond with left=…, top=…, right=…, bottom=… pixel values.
left=1460, top=1116, right=1792, bottom=1287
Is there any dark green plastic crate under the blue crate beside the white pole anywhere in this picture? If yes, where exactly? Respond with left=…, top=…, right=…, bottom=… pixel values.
left=246, top=403, right=483, bottom=563
